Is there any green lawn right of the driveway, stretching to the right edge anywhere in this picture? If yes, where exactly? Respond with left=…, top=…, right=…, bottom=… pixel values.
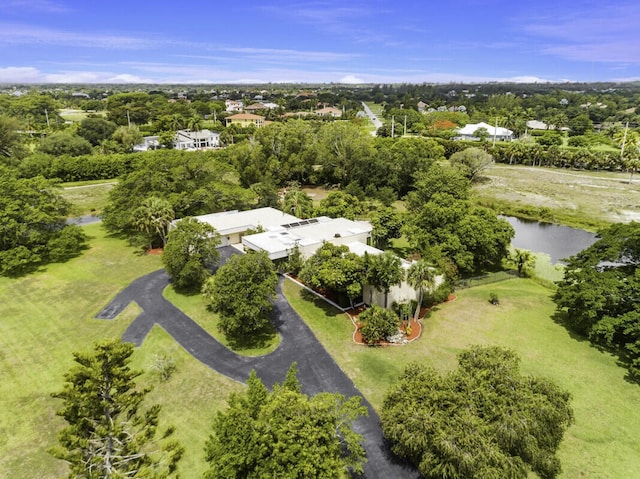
left=285, top=279, right=640, bottom=479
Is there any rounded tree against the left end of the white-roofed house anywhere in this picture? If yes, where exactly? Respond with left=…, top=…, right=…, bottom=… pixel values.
left=162, top=218, right=220, bottom=291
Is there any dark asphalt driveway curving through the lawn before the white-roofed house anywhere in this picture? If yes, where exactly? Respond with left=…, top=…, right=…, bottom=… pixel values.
left=96, top=264, right=420, bottom=479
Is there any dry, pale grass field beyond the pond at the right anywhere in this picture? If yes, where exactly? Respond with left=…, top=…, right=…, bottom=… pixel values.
left=473, top=165, right=640, bottom=231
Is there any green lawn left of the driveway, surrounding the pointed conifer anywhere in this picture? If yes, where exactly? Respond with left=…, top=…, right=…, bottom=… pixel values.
left=0, top=225, right=241, bottom=478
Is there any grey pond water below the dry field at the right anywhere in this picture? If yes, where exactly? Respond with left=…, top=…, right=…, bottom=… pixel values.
left=501, top=216, right=596, bottom=264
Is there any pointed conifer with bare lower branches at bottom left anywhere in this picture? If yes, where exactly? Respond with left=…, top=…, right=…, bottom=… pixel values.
left=51, top=341, right=183, bottom=479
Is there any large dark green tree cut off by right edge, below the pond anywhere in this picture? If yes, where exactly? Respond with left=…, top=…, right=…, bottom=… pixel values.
left=554, top=222, right=640, bottom=381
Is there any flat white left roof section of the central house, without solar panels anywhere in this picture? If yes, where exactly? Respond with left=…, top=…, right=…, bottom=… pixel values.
left=186, top=207, right=300, bottom=235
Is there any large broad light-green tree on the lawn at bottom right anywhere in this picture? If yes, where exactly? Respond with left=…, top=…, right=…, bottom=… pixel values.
left=381, top=346, right=573, bottom=479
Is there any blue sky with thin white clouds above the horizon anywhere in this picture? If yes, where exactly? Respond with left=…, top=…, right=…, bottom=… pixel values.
left=0, top=0, right=640, bottom=83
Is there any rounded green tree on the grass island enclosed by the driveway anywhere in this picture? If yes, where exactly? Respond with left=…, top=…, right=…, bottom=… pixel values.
left=202, top=251, right=278, bottom=339
